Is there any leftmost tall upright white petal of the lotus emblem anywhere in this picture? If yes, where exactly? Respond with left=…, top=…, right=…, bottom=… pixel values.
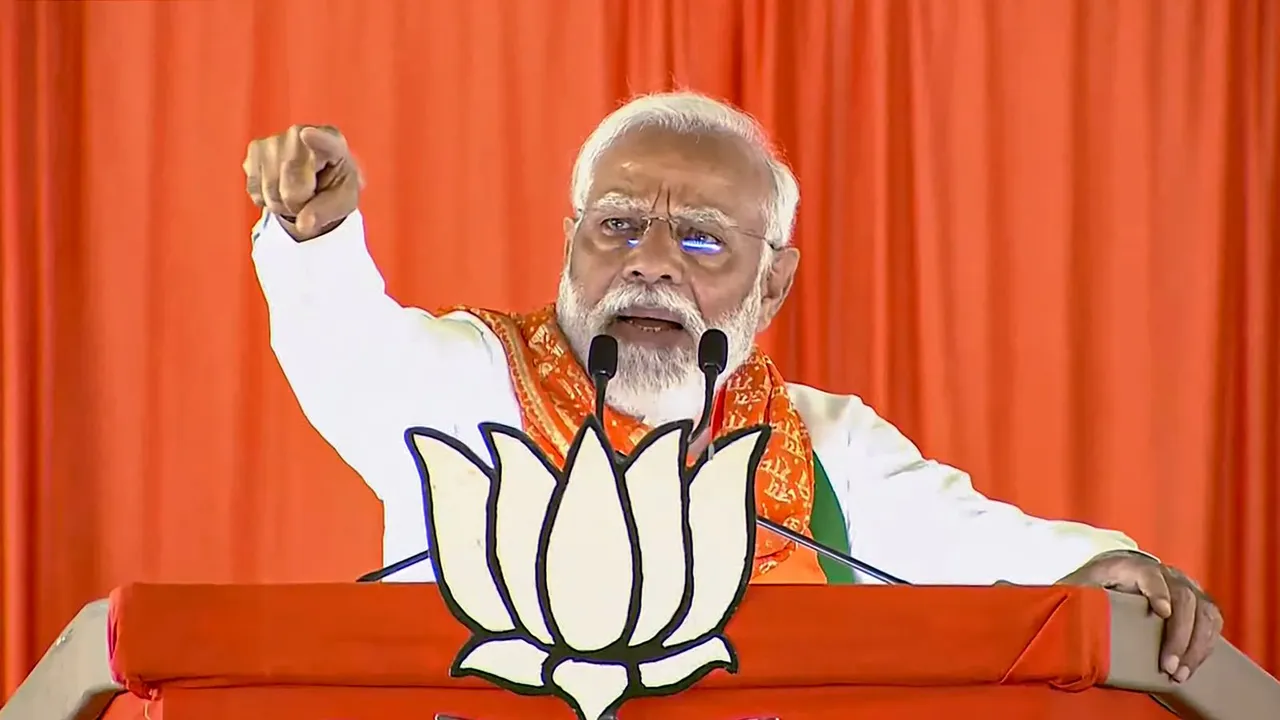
left=412, top=430, right=516, bottom=633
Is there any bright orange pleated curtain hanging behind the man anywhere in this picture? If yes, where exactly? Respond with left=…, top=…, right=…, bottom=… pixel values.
left=0, top=0, right=1280, bottom=693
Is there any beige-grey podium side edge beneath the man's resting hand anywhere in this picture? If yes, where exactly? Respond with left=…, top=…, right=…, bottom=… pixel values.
left=1105, top=592, right=1280, bottom=720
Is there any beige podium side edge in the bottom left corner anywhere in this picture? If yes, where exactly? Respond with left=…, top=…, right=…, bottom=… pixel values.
left=0, top=598, right=124, bottom=720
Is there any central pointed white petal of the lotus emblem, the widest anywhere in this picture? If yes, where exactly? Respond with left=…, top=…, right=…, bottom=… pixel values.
left=545, top=425, right=634, bottom=652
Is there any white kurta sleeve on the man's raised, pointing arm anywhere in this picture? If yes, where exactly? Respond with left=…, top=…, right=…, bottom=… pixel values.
left=252, top=207, right=509, bottom=499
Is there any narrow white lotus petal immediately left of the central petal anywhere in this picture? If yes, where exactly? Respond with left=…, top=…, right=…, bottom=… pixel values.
left=489, top=432, right=556, bottom=646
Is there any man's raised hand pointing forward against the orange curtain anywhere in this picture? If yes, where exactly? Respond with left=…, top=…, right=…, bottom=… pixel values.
left=243, top=126, right=365, bottom=240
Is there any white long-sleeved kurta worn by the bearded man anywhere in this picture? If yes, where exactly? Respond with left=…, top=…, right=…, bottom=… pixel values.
left=253, top=207, right=1135, bottom=584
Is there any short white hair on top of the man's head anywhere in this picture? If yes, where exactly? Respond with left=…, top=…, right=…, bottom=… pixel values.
left=570, top=91, right=800, bottom=247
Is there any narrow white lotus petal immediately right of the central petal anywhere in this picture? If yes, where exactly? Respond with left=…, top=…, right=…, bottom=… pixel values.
left=626, top=424, right=685, bottom=646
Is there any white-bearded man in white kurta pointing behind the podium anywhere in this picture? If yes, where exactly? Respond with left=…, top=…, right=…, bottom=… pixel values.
left=244, top=94, right=1221, bottom=680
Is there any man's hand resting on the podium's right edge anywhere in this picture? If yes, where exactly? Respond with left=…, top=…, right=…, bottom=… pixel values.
left=1061, top=551, right=1222, bottom=683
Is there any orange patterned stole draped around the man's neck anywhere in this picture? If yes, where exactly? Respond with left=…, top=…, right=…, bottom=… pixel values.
left=449, top=305, right=827, bottom=584
